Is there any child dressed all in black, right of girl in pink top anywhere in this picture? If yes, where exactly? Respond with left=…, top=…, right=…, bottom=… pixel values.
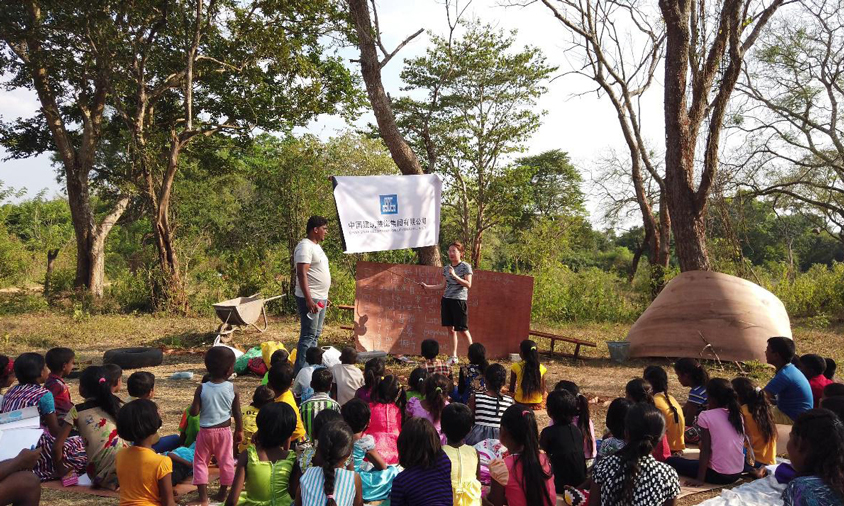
left=539, top=390, right=586, bottom=492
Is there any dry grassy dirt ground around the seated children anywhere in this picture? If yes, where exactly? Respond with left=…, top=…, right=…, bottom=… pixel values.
left=0, top=313, right=844, bottom=506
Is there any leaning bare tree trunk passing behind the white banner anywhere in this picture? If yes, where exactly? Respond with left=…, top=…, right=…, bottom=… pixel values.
left=348, top=0, right=442, bottom=267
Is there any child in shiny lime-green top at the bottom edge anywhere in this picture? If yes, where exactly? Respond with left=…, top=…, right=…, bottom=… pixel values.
left=226, top=400, right=300, bottom=506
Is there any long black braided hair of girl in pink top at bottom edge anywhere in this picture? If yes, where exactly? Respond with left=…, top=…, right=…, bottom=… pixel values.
left=501, top=404, right=556, bottom=506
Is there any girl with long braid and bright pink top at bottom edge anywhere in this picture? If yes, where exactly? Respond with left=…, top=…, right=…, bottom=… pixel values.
left=487, top=404, right=557, bottom=506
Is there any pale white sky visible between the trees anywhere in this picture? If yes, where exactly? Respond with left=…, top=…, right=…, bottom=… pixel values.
left=0, top=0, right=664, bottom=226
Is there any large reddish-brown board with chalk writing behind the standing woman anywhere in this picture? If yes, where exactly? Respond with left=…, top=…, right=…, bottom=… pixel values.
left=355, top=262, right=533, bottom=358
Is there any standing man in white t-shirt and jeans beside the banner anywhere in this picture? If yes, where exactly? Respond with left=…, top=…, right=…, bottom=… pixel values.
left=293, top=216, right=331, bottom=374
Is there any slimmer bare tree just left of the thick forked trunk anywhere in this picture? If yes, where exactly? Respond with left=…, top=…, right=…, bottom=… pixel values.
left=531, top=0, right=671, bottom=292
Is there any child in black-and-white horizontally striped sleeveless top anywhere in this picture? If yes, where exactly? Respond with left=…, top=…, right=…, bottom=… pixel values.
left=466, top=364, right=516, bottom=446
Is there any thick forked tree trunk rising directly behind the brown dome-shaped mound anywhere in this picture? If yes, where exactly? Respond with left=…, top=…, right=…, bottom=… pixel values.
left=659, top=0, right=793, bottom=271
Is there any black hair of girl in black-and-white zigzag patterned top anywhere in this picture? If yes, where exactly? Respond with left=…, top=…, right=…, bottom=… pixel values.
left=607, top=402, right=665, bottom=504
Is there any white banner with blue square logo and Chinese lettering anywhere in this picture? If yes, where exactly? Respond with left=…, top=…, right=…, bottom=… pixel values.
left=334, top=174, right=442, bottom=253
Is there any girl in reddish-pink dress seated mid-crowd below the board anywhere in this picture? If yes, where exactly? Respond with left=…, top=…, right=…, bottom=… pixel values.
left=366, top=375, right=407, bottom=465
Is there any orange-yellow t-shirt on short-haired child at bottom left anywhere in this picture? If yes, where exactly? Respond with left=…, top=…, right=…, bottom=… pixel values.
left=117, top=446, right=173, bottom=506
